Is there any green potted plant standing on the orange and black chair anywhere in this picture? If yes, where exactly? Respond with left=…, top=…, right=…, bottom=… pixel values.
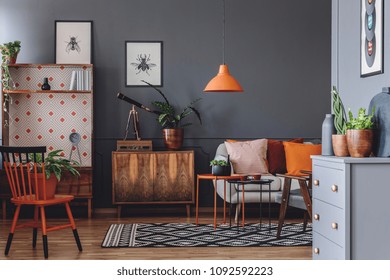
left=31, top=150, right=80, bottom=199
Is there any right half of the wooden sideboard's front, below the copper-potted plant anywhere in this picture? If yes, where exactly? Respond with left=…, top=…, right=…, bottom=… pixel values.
left=153, top=152, right=194, bottom=203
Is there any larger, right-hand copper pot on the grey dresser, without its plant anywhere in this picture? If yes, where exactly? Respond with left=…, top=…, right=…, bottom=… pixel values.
left=347, top=129, right=374, bottom=157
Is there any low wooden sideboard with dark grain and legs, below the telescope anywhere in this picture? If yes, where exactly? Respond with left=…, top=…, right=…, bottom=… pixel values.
left=112, top=151, right=194, bottom=217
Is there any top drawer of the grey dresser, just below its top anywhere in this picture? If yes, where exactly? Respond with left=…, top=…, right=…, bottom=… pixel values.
left=313, top=163, right=345, bottom=208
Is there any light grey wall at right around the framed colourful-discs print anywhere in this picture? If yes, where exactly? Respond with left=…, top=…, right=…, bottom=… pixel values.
left=332, top=0, right=390, bottom=115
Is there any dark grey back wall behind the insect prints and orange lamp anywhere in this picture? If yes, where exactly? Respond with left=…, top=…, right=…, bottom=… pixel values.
left=0, top=0, right=331, bottom=207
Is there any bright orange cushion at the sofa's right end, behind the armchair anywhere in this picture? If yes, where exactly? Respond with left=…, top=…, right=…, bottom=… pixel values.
left=283, top=142, right=321, bottom=176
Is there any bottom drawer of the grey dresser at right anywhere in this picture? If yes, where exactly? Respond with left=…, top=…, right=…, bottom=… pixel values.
left=312, top=232, right=346, bottom=260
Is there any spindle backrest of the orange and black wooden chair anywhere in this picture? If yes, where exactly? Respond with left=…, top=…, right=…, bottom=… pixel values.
left=0, top=146, right=46, bottom=200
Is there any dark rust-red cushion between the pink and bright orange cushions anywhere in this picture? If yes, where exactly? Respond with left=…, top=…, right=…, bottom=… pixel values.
left=267, top=138, right=303, bottom=174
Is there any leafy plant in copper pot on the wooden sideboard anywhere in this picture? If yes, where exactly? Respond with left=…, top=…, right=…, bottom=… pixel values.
left=142, top=80, right=202, bottom=150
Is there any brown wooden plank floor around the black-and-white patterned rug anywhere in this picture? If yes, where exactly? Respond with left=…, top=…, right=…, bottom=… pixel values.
left=0, top=214, right=311, bottom=260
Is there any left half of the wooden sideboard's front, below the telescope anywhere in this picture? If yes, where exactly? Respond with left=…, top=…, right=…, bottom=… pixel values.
left=112, top=152, right=154, bottom=204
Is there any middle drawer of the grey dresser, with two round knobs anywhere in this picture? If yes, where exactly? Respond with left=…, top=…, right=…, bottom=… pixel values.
left=313, top=199, right=345, bottom=247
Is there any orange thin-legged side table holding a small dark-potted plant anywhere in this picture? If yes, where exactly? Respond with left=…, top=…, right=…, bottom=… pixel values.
left=195, top=174, right=242, bottom=229
